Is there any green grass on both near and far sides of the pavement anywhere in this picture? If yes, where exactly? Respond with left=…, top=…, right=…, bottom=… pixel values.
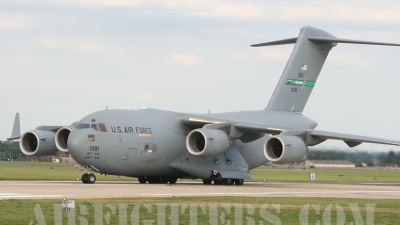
left=0, top=162, right=400, bottom=225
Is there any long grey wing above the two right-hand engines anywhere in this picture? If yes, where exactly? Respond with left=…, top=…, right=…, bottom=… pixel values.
left=233, top=122, right=400, bottom=147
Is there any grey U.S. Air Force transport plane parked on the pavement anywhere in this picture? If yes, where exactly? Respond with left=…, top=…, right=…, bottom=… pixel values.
left=8, top=27, right=400, bottom=185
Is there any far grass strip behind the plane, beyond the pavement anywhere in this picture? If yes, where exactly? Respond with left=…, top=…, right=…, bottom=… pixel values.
left=0, top=162, right=400, bottom=183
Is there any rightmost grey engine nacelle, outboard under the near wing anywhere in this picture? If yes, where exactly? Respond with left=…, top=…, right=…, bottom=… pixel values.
left=264, top=135, right=308, bottom=163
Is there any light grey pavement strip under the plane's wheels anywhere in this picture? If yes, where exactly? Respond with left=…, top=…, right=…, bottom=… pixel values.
left=0, top=181, right=400, bottom=199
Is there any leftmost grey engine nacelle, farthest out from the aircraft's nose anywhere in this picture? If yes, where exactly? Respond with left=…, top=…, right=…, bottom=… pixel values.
left=19, top=130, right=57, bottom=156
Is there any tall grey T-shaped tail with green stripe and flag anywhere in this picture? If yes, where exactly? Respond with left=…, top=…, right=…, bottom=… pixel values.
left=251, top=27, right=400, bottom=113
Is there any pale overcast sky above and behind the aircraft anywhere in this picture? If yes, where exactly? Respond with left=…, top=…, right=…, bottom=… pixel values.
left=0, top=0, right=400, bottom=149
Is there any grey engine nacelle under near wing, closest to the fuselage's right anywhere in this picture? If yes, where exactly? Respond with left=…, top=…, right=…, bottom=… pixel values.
left=186, top=128, right=231, bottom=156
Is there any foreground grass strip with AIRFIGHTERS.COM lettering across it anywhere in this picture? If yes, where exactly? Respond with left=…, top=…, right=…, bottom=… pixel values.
left=0, top=197, right=400, bottom=225
